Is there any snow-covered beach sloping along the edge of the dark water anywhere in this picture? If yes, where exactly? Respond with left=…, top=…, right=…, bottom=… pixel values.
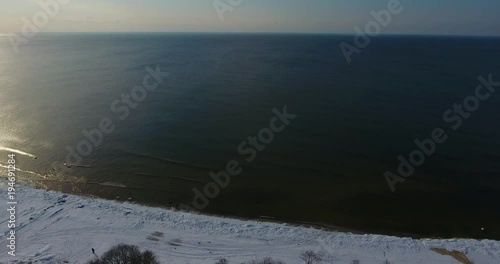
left=0, top=185, right=500, bottom=264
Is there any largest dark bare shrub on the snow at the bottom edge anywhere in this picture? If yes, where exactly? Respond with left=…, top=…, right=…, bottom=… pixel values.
left=87, top=244, right=160, bottom=264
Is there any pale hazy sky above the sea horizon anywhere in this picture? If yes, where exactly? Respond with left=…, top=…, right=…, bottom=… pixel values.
left=0, top=0, right=500, bottom=36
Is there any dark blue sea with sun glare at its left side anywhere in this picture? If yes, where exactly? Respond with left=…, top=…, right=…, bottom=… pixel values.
left=0, top=34, right=500, bottom=238
